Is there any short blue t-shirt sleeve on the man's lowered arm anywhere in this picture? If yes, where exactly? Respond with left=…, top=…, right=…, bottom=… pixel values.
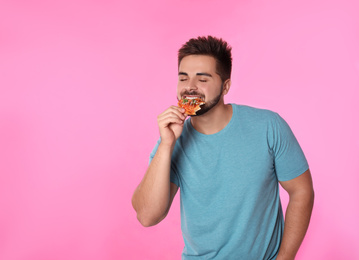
left=268, top=113, right=309, bottom=181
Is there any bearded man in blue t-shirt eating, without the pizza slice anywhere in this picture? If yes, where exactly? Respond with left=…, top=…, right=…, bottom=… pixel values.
left=132, top=36, right=314, bottom=260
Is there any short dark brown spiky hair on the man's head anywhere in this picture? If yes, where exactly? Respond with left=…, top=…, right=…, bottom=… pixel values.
left=178, top=36, right=232, bottom=82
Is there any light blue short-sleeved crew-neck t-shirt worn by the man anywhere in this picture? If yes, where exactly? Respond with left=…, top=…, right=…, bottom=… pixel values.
left=150, top=104, right=308, bottom=260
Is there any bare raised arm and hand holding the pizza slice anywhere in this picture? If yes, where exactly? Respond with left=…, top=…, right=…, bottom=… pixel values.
left=132, top=106, right=186, bottom=227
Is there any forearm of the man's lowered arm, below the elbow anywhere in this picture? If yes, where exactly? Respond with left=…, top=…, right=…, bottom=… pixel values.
left=277, top=191, right=314, bottom=260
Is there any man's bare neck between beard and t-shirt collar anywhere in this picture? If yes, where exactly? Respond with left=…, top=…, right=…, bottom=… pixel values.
left=191, top=99, right=233, bottom=135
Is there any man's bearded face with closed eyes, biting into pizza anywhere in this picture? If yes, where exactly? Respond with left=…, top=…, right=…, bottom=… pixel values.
left=177, top=55, right=223, bottom=115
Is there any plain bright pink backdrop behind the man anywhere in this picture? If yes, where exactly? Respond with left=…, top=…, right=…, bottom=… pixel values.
left=0, top=0, right=359, bottom=260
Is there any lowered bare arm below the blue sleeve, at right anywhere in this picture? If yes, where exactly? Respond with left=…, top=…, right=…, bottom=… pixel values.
left=277, top=170, right=314, bottom=260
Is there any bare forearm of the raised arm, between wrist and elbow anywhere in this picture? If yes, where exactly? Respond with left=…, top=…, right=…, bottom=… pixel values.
left=132, top=144, right=173, bottom=226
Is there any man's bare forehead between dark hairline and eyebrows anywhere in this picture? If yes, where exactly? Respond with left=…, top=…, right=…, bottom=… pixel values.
left=179, top=55, right=216, bottom=73
